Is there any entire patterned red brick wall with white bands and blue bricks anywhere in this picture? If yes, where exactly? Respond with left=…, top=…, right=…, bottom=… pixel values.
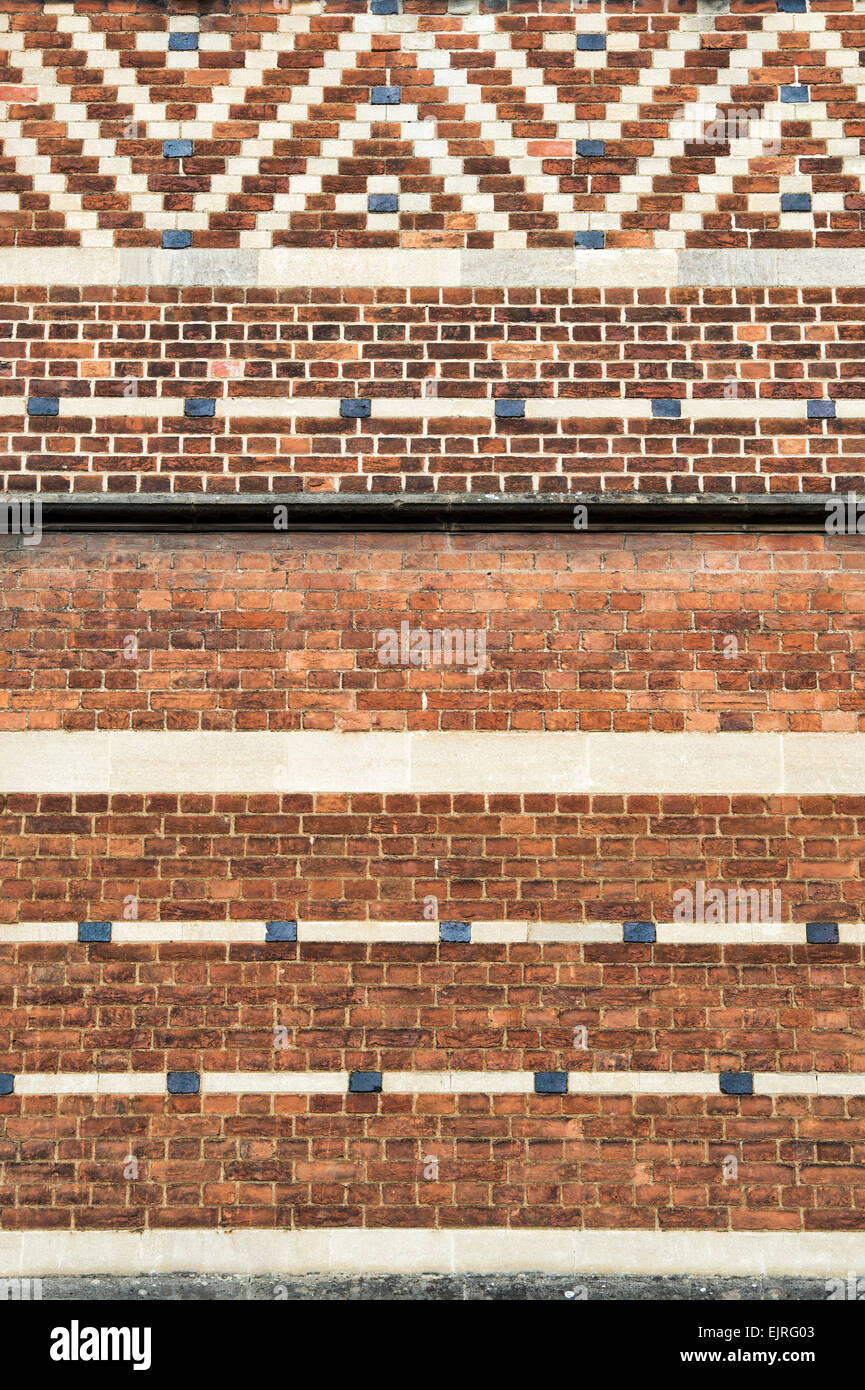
left=0, top=0, right=865, bottom=1276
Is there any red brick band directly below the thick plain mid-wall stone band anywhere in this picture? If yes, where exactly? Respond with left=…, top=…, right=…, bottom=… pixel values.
left=0, top=792, right=865, bottom=922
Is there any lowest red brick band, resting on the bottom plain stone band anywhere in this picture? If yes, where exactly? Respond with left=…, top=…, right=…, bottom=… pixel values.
left=0, top=1095, right=865, bottom=1232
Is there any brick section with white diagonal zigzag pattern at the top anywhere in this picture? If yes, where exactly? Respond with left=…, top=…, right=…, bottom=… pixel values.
left=0, top=0, right=865, bottom=249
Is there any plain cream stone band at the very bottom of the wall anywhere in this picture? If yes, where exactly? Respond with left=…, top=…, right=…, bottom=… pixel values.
left=0, top=1227, right=865, bottom=1273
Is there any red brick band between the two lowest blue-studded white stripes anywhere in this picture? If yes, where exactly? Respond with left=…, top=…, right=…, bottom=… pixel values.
left=0, top=945, right=865, bottom=1088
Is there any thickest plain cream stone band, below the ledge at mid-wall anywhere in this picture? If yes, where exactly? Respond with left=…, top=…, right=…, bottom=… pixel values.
left=0, top=728, right=865, bottom=795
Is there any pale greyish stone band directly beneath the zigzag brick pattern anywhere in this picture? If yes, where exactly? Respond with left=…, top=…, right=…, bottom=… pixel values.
left=1, top=246, right=862, bottom=289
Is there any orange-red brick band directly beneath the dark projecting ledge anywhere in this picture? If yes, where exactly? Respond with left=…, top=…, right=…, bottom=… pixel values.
left=0, top=532, right=865, bottom=733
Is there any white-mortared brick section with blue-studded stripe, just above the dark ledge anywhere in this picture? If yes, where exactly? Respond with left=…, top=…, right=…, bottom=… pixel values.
left=0, top=286, right=865, bottom=496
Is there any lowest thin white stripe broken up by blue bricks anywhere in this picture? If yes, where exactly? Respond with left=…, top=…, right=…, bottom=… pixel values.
left=8, top=1070, right=865, bottom=1095
